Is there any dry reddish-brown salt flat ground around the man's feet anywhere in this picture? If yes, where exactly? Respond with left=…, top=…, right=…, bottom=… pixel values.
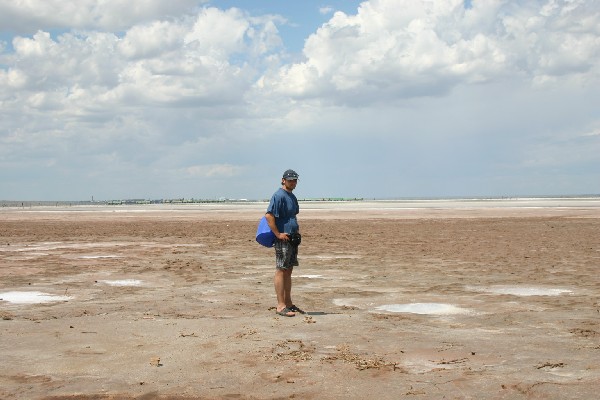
left=0, top=209, right=600, bottom=399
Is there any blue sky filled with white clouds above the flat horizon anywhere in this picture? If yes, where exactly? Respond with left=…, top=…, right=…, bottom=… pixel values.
left=0, top=0, right=600, bottom=201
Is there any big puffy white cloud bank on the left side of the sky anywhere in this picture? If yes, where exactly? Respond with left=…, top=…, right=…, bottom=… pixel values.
left=0, top=8, right=278, bottom=122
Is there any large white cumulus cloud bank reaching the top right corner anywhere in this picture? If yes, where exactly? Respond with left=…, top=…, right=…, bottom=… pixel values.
left=264, top=0, right=600, bottom=104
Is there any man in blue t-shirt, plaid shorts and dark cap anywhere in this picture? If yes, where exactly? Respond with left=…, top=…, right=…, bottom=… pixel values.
left=265, top=169, right=304, bottom=317
